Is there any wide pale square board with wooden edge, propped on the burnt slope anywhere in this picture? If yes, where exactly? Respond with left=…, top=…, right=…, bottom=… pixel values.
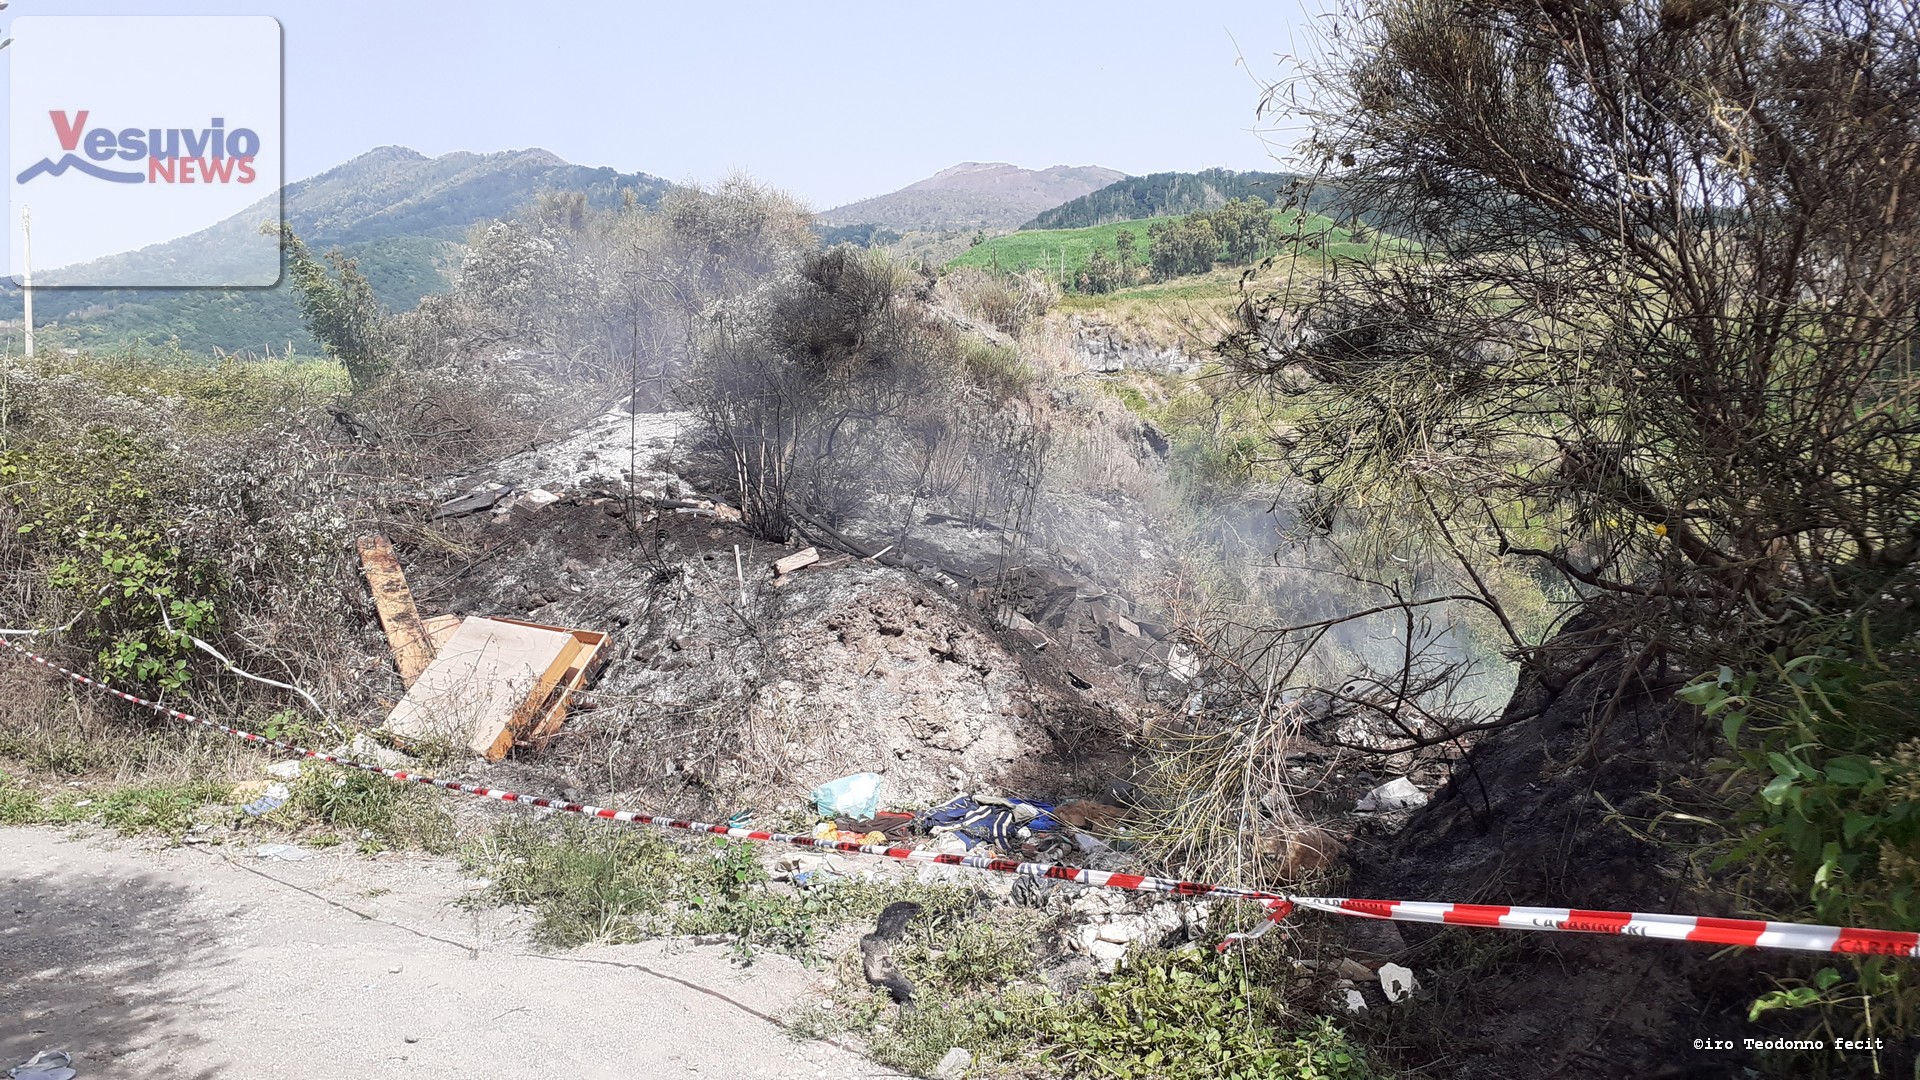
left=386, top=617, right=584, bottom=761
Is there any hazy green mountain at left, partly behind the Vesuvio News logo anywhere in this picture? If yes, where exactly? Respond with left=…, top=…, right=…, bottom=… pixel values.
left=0, top=146, right=670, bottom=354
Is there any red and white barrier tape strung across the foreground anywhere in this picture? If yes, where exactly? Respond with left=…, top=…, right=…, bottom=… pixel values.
left=0, top=636, right=1920, bottom=957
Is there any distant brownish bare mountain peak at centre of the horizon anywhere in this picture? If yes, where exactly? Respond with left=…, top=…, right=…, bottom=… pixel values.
left=816, top=161, right=1125, bottom=229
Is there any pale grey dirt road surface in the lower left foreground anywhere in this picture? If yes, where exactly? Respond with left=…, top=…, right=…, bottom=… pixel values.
left=0, top=828, right=897, bottom=1080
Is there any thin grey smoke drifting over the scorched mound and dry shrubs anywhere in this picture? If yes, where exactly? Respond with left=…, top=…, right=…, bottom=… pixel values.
left=403, top=177, right=1513, bottom=749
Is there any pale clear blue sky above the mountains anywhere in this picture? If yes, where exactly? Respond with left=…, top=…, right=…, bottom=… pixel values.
left=0, top=0, right=1323, bottom=209
